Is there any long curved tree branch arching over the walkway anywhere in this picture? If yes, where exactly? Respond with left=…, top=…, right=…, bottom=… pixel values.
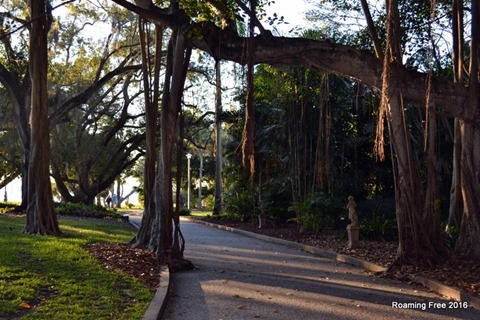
left=113, top=0, right=472, bottom=125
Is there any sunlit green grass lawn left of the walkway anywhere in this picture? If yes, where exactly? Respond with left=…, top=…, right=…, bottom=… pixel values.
left=0, top=216, right=153, bottom=320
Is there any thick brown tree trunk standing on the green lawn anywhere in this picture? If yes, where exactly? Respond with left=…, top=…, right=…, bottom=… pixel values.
left=24, top=0, right=60, bottom=235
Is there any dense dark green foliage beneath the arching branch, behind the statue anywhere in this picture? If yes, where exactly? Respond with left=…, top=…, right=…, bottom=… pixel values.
left=221, top=58, right=393, bottom=233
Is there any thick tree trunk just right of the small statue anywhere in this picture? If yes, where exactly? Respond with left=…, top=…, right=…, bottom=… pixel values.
left=381, top=0, right=444, bottom=264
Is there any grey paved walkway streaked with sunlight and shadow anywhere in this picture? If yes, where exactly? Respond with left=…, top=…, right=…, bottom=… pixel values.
left=163, top=221, right=480, bottom=320
